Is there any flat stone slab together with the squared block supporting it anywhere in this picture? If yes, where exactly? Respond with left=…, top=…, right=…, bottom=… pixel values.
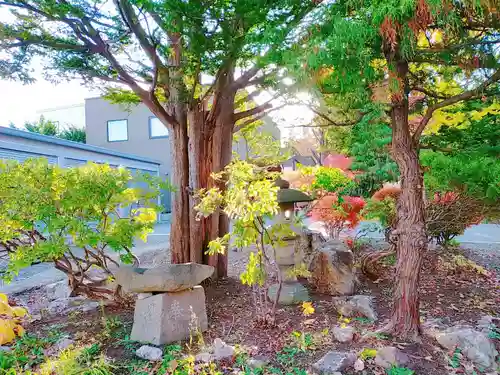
left=115, top=263, right=214, bottom=345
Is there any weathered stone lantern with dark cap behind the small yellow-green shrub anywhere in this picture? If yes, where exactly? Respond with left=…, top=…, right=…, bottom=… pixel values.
left=268, top=179, right=312, bottom=305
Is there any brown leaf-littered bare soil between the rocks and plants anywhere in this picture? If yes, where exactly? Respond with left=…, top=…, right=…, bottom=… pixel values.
left=26, top=245, right=500, bottom=375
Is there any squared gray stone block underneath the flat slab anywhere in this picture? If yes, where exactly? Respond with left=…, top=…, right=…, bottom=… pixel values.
left=130, top=285, right=208, bottom=345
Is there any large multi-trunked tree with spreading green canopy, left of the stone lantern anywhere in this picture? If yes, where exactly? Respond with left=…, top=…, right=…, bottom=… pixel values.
left=0, top=0, right=317, bottom=274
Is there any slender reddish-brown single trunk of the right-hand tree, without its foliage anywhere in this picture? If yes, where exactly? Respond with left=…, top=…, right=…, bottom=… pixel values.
left=388, top=61, right=427, bottom=339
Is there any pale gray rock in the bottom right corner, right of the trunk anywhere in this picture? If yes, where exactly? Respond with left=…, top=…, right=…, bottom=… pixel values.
left=436, top=326, right=498, bottom=369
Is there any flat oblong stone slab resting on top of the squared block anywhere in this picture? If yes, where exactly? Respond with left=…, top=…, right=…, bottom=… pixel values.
left=115, top=263, right=214, bottom=293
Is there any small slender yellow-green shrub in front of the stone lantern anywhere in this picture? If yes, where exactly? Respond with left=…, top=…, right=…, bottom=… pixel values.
left=195, top=160, right=293, bottom=319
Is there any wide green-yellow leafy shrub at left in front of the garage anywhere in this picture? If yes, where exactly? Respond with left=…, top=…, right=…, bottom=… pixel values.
left=0, top=159, right=163, bottom=293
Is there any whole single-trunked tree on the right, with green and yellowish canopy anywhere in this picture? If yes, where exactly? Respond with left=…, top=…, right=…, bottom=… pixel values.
left=282, top=0, right=500, bottom=337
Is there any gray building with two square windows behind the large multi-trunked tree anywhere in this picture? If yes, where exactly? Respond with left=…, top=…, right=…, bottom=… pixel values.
left=85, top=97, right=280, bottom=212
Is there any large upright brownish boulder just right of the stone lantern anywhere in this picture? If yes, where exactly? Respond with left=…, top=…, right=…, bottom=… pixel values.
left=309, top=240, right=356, bottom=296
